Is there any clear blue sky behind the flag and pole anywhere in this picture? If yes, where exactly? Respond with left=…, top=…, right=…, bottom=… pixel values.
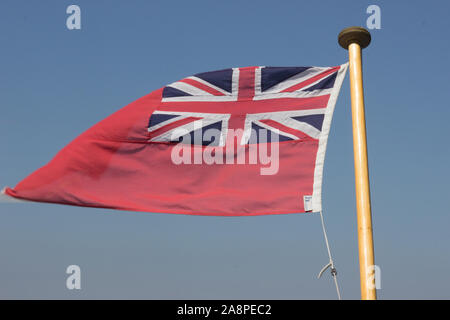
left=0, top=0, right=450, bottom=299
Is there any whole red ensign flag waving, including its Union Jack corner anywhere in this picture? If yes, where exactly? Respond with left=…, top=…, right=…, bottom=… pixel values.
left=2, top=64, right=347, bottom=216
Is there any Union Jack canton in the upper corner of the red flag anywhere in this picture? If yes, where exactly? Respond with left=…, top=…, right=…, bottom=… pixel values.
left=148, top=65, right=346, bottom=146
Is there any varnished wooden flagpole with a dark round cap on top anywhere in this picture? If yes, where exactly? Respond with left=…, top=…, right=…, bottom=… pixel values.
left=338, top=27, right=377, bottom=300
